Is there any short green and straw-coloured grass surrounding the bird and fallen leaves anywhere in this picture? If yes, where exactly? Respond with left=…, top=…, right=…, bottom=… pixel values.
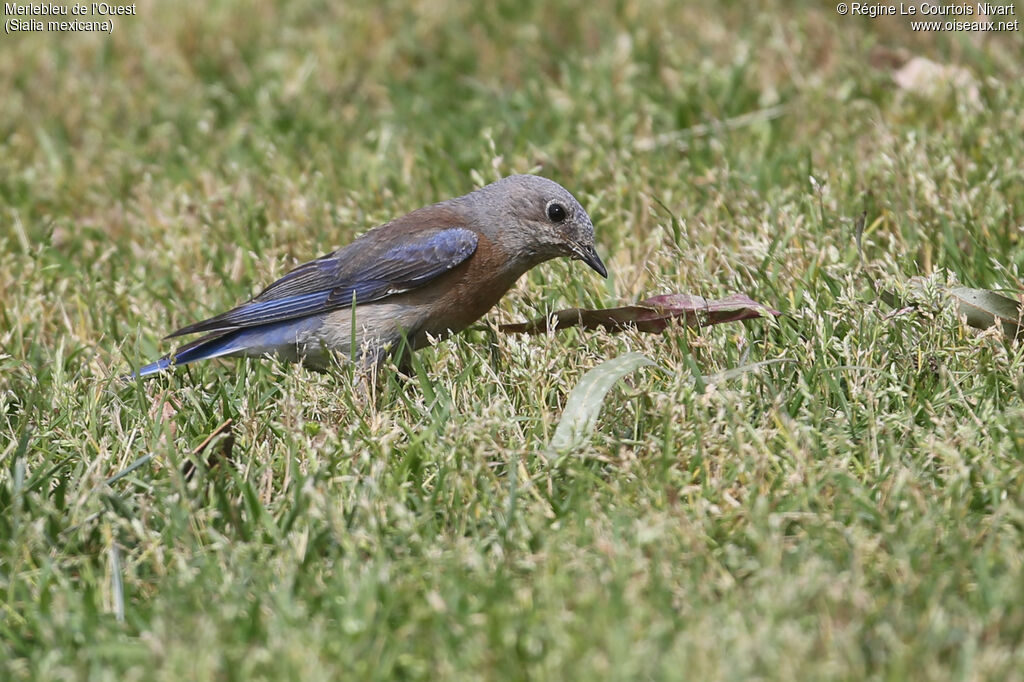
left=0, top=0, right=1024, bottom=680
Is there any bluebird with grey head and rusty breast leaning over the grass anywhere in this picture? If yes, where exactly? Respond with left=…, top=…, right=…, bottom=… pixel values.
left=130, top=175, right=608, bottom=378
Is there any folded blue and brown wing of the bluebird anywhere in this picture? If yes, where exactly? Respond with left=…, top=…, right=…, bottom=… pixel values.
left=168, top=225, right=477, bottom=338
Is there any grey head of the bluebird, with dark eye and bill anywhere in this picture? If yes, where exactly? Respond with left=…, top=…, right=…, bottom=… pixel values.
left=452, top=175, right=608, bottom=278
